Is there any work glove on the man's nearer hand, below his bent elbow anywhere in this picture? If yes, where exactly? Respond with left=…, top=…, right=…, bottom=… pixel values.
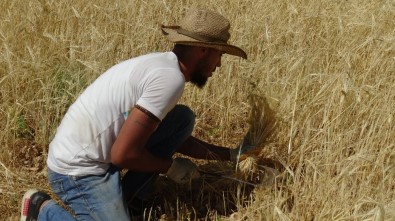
left=165, top=157, right=200, bottom=184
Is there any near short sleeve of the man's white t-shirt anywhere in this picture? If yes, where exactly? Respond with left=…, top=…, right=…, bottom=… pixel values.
left=137, top=69, right=185, bottom=120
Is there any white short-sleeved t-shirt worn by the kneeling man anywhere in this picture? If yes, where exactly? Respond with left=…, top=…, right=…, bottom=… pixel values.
left=47, top=52, right=185, bottom=176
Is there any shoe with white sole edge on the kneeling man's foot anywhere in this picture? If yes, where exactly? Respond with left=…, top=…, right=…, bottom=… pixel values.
left=21, top=189, right=51, bottom=221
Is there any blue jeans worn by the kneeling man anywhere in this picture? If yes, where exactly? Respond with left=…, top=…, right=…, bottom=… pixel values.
left=38, top=105, right=195, bottom=221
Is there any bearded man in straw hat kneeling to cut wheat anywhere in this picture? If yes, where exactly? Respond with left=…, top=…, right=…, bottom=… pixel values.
left=21, top=9, right=247, bottom=221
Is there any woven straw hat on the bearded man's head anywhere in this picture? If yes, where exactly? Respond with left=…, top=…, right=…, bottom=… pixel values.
left=162, top=9, right=247, bottom=59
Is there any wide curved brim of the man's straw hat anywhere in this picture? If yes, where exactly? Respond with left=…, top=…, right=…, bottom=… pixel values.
left=162, top=26, right=247, bottom=59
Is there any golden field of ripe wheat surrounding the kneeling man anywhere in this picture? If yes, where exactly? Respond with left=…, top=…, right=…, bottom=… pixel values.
left=0, top=0, right=395, bottom=221
